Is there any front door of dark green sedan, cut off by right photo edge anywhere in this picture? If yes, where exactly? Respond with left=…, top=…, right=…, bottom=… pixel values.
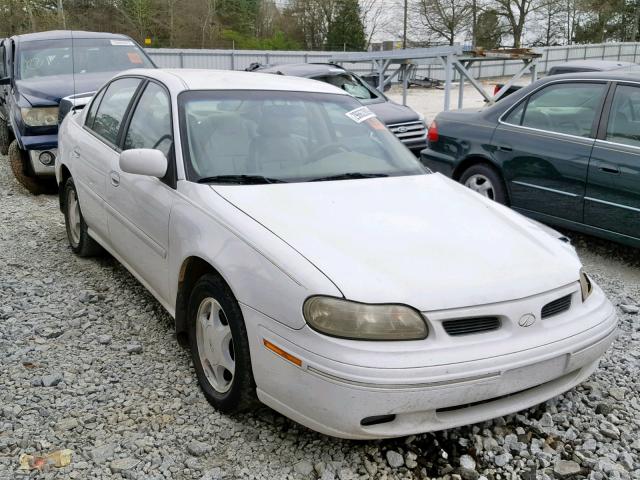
left=584, top=83, right=640, bottom=238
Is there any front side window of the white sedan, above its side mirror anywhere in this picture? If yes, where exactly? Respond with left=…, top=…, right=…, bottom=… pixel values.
left=124, top=83, right=173, bottom=156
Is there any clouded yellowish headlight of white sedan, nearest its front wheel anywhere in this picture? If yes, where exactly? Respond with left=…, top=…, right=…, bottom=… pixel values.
left=303, top=296, right=429, bottom=340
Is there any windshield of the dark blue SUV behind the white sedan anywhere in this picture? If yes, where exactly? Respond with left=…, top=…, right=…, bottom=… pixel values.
left=17, top=38, right=153, bottom=80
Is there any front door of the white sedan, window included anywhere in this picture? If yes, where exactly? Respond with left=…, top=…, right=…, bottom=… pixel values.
left=106, top=81, right=176, bottom=301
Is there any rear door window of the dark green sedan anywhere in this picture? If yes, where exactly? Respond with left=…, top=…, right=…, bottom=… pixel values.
left=522, top=83, right=605, bottom=137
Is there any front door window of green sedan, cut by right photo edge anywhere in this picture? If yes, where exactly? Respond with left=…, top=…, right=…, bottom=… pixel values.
left=605, top=85, right=640, bottom=147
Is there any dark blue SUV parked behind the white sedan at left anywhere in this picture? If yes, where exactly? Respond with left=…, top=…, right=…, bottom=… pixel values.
left=0, top=31, right=154, bottom=193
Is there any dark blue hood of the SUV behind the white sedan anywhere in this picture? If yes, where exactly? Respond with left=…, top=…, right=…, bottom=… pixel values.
left=16, top=72, right=115, bottom=106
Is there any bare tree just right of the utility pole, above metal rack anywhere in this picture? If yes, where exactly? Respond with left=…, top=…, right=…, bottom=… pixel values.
left=417, top=0, right=473, bottom=45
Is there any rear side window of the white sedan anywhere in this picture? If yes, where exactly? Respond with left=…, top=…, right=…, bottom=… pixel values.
left=91, top=78, right=140, bottom=145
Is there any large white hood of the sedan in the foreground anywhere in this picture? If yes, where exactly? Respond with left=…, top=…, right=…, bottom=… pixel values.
left=212, top=174, right=580, bottom=311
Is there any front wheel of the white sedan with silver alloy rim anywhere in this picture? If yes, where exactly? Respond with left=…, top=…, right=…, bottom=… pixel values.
left=187, top=274, right=259, bottom=414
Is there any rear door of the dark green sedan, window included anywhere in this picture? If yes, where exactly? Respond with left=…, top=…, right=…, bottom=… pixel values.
left=491, top=82, right=607, bottom=222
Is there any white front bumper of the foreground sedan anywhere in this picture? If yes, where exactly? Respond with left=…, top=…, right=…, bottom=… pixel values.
left=242, top=284, right=617, bottom=439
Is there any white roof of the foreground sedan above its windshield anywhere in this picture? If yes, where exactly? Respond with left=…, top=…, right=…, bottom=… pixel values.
left=118, top=68, right=350, bottom=96
